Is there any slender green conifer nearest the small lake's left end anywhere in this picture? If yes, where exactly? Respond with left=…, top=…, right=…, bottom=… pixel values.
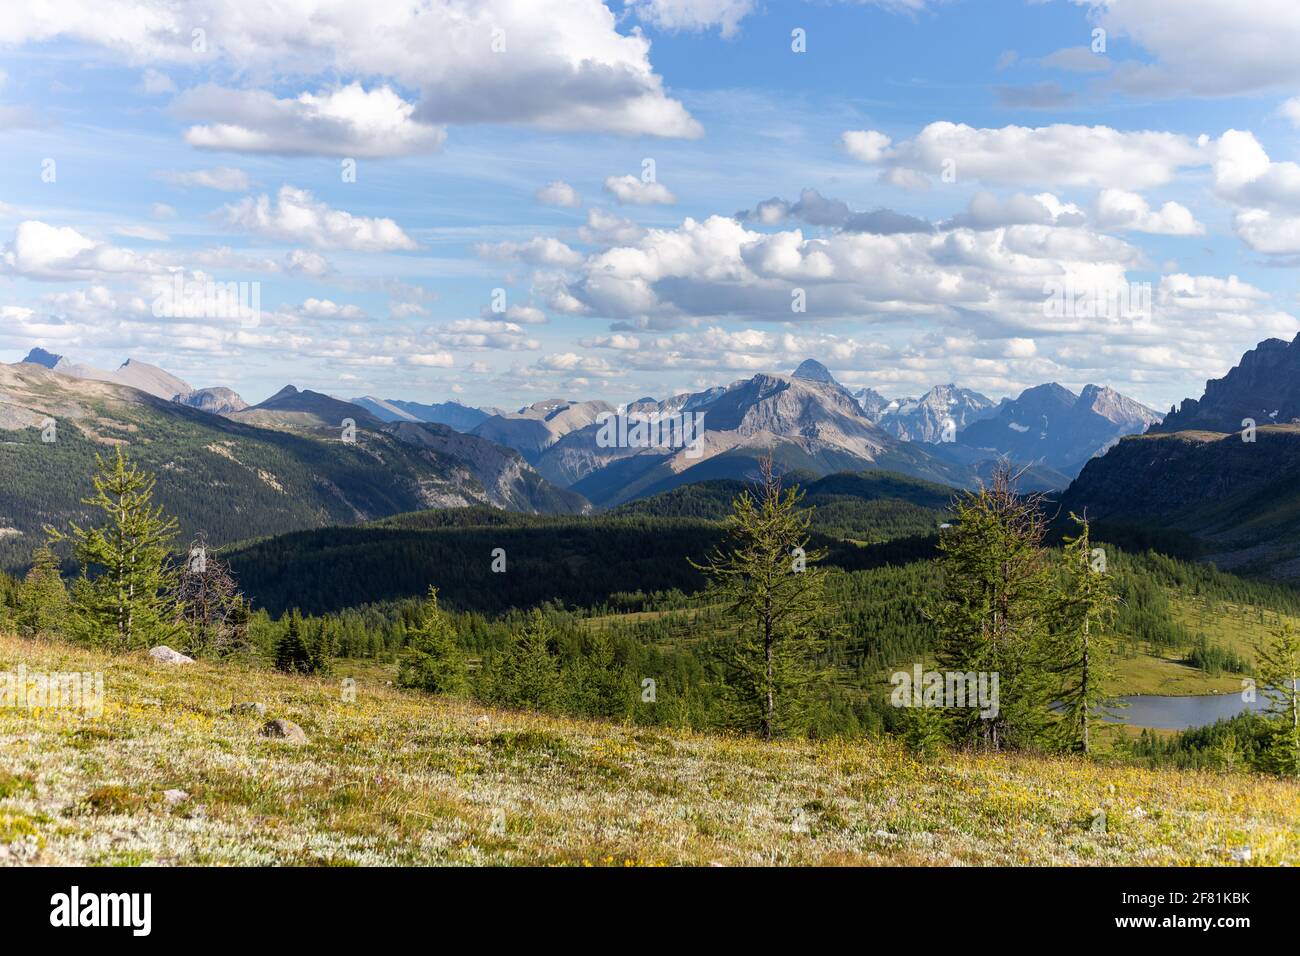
left=1052, top=514, right=1119, bottom=753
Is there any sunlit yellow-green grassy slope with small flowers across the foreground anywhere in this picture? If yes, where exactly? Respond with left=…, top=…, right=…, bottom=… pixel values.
left=0, top=636, right=1300, bottom=865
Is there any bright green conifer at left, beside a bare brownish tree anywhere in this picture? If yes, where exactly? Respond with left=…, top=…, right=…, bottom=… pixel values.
left=47, top=446, right=182, bottom=650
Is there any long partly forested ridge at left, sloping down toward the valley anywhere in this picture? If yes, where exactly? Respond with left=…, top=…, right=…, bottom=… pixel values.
left=0, top=363, right=590, bottom=567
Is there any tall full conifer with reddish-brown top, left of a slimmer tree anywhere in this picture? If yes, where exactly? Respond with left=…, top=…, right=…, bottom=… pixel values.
left=928, top=464, right=1052, bottom=750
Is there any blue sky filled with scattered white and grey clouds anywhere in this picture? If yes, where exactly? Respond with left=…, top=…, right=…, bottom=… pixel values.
left=0, top=0, right=1300, bottom=407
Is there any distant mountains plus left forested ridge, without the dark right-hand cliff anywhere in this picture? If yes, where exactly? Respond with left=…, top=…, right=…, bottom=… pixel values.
left=0, top=349, right=1157, bottom=567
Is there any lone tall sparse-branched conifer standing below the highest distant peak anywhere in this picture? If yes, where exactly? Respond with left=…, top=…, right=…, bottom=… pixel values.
left=692, top=455, right=829, bottom=740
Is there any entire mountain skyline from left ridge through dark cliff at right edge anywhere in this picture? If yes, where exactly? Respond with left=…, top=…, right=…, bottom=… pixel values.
left=15, top=329, right=1300, bottom=616
